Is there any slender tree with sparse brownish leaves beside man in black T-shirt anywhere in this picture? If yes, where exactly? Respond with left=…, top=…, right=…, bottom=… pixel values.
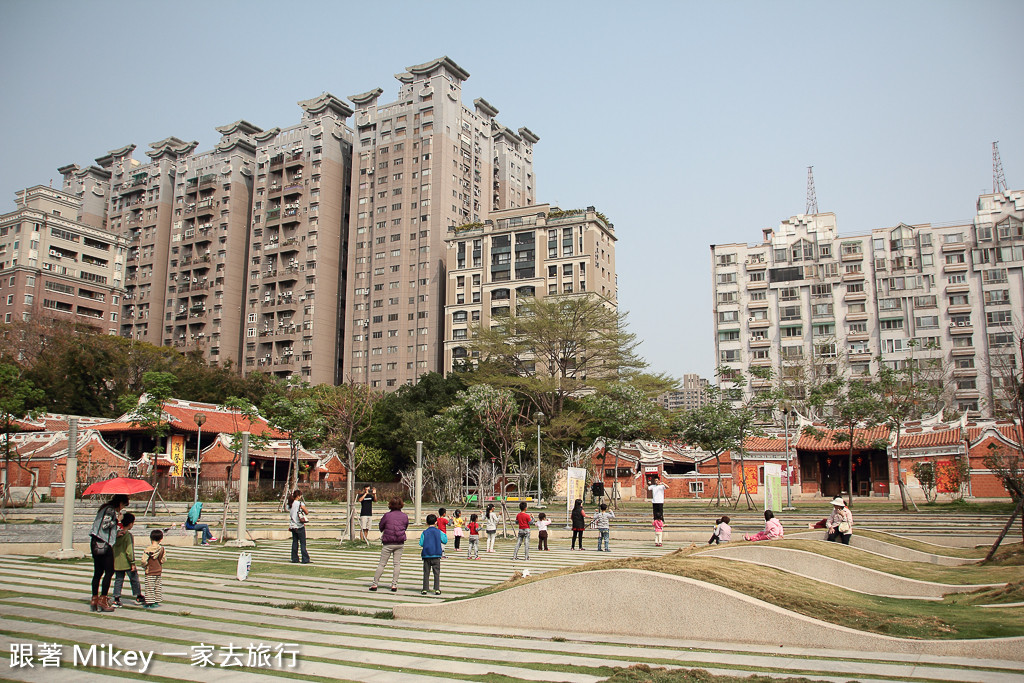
left=313, top=382, right=381, bottom=540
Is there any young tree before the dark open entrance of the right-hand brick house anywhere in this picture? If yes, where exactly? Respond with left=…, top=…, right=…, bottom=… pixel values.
left=804, top=378, right=887, bottom=507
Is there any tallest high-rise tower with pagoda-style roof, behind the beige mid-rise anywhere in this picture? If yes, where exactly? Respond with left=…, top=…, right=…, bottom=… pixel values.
left=341, top=57, right=539, bottom=389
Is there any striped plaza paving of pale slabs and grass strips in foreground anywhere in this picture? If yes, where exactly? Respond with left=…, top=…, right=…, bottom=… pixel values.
left=0, top=537, right=1024, bottom=683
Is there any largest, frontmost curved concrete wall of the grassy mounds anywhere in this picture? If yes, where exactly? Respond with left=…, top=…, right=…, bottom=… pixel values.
left=394, top=569, right=1024, bottom=661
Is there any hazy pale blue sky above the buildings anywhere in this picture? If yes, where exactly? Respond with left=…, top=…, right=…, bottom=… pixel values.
left=0, top=0, right=1024, bottom=378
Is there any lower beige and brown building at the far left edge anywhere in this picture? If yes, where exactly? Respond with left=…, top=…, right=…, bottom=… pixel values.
left=0, top=184, right=126, bottom=327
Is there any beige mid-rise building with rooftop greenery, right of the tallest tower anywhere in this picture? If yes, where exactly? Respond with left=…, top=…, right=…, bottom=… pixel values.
left=443, top=204, right=618, bottom=373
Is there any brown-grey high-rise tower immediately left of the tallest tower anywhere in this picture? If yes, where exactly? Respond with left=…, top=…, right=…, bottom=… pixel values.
left=242, top=93, right=352, bottom=384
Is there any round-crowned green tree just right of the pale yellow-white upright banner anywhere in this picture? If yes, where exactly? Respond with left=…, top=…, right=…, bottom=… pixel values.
left=580, top=382, right=669, bottom=509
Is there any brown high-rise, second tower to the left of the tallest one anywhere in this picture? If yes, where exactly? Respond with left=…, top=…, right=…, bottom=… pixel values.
left=163, top=121, right=261, bottom=366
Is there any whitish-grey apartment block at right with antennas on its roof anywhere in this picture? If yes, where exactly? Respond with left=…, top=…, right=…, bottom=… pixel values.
left=711, top=191, right=1024, bottom=415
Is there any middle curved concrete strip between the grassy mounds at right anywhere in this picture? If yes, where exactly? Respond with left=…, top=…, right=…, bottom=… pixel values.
left=700, top=543, right=1002, bottom=598
